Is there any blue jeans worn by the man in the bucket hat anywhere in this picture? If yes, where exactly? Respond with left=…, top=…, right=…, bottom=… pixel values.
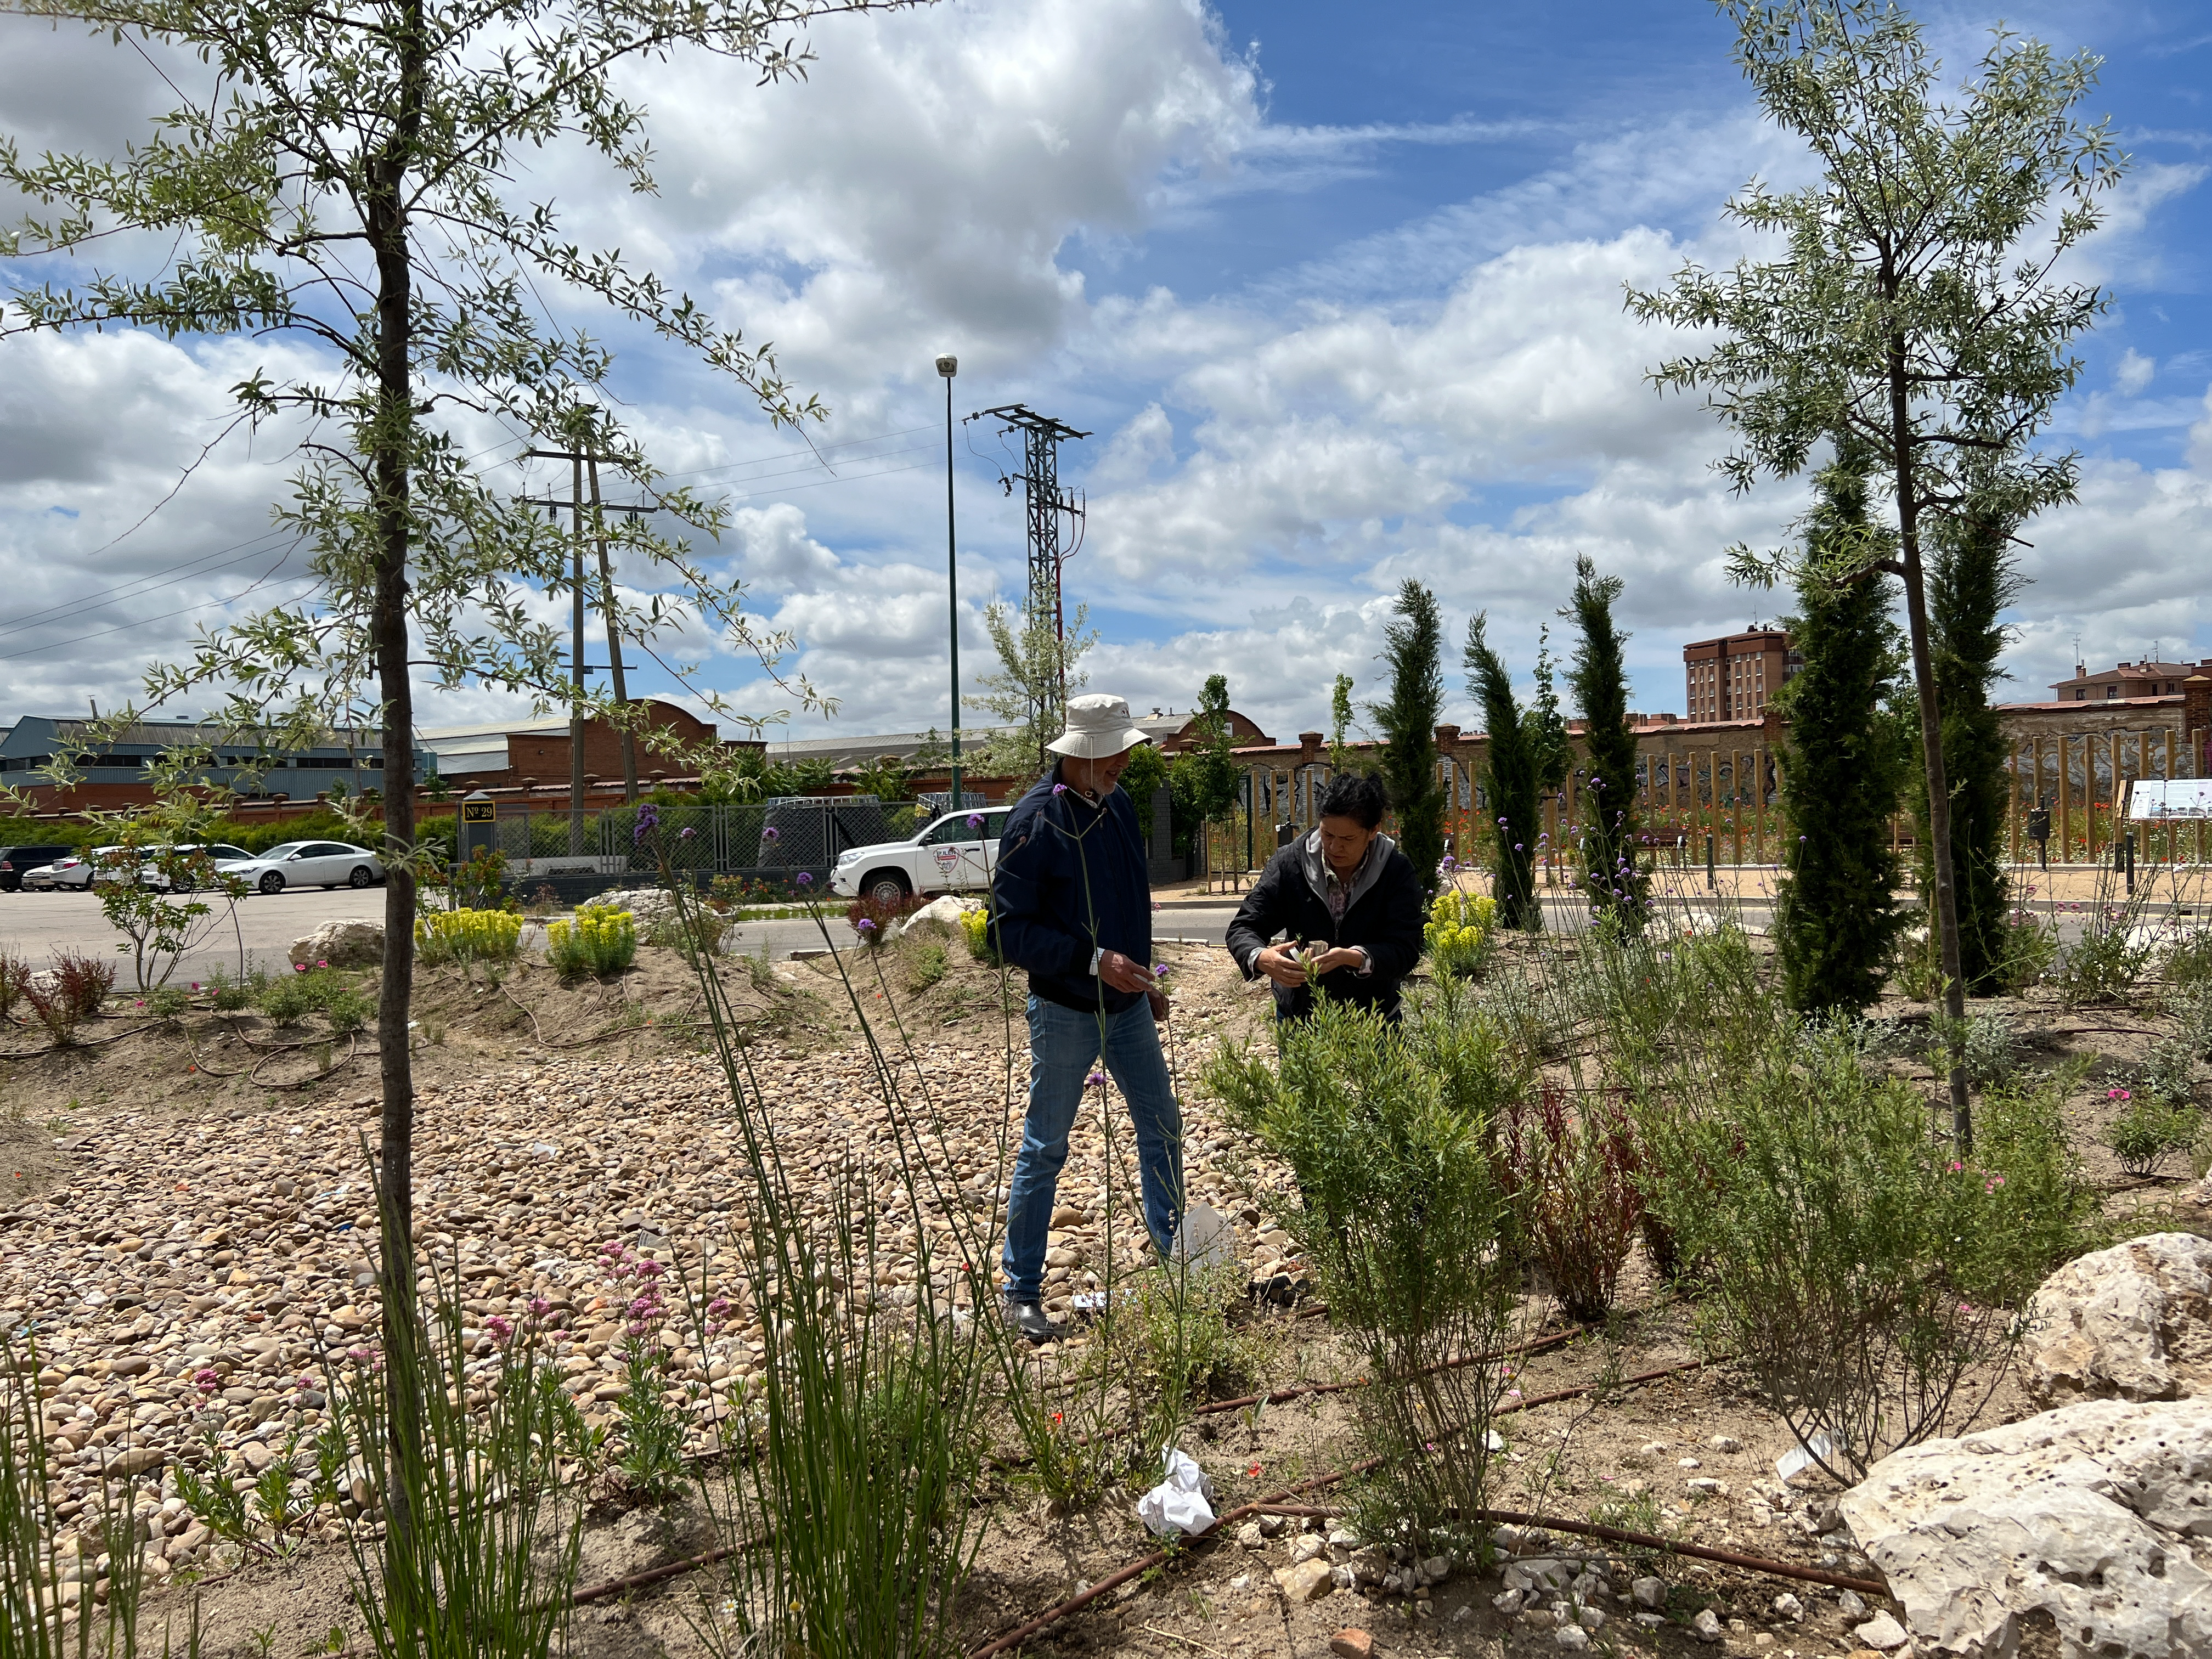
left=1002, top=997, right=1183, bottom=1303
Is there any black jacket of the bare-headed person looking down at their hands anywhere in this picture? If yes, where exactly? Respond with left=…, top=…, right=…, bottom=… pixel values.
left=1230, top=830, right=1429, bottom=1020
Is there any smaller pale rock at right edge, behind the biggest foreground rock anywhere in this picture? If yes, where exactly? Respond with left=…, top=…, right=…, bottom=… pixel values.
left=2028, top=1232, right=2212, bottom=1404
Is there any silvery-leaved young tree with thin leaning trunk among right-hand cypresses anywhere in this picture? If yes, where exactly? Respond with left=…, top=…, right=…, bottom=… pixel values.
left=1628, top=0, right=2124, bottom=1155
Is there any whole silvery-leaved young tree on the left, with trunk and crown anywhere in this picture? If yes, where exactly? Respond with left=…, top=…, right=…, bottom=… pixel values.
left=0, top=0, right=896, bottom=1601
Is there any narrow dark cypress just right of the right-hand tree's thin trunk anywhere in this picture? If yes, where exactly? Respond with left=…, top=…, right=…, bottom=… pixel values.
left=1920, top=502, right=2019, bottom=995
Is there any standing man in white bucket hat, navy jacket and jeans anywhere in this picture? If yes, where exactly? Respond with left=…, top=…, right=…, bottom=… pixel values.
left=991, top=695, right=1183, bottom=1342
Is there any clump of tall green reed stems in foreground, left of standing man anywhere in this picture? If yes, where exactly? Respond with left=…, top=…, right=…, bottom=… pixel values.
left=670, top=883, right=995, bottom=1659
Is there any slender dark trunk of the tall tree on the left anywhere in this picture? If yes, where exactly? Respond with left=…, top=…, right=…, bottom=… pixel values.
left=365, top=2, right=425, bottom=1601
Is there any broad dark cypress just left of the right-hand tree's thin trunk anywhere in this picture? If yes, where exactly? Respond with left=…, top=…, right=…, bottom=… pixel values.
left=1774, top=462, right=1907, bottom=1013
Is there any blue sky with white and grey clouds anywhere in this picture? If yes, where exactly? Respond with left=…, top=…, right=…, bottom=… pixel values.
left=0, top=0, right=2212, bottom=737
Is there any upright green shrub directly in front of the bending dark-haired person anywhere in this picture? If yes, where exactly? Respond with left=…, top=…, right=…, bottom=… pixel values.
left=1205, top=1000, right=1515, bottom=1533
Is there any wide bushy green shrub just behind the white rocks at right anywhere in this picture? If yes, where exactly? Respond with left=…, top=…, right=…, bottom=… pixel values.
left=1652, top=1022, right=2095, bottom=1477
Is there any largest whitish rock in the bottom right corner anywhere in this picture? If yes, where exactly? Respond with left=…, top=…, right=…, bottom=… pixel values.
left=1843, top=1400, right=2212, bottom=1659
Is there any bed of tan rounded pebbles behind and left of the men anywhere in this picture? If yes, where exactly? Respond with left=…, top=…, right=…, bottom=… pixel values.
left=0, top=1044, right=1299, bottom=1601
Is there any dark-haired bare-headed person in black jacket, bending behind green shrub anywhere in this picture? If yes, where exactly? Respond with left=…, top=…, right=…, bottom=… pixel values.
left=1228, top=772, right=1427, bottom=1020
